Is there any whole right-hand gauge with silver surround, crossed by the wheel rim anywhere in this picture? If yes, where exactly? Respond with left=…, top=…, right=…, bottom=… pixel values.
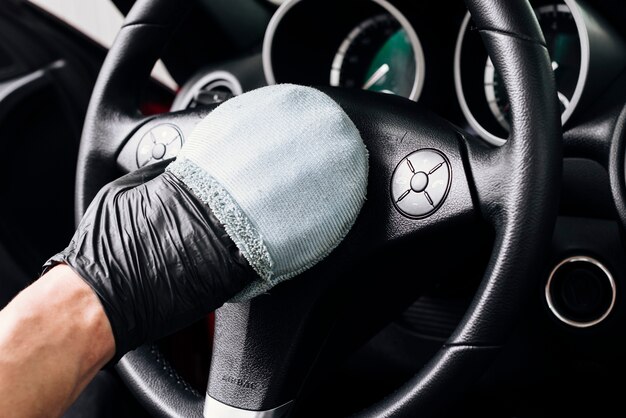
left=454, top=0, right=626, bottom=146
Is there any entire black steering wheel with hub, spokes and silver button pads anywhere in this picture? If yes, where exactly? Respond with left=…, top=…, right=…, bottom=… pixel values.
left=76, top=0, right=562, bottom=417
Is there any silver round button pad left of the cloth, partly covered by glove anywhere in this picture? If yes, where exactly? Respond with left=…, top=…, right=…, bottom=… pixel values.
left=137, top=123, right=183, bottom=168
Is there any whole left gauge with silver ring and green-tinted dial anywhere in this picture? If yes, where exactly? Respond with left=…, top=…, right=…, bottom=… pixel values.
left=262, top=0, right=425, bottom=101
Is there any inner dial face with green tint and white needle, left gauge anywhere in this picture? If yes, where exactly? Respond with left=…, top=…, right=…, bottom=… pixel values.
left=330, top=13, right=423, bottom=100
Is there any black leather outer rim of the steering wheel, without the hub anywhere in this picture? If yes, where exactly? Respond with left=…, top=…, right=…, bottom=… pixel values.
left=75, top=0, right=561, bottom=417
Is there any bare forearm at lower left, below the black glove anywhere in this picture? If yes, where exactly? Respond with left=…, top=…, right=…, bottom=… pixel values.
left=0, top=266, right=115, bottom=418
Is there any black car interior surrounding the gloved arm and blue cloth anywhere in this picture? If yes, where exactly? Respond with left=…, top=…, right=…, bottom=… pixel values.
left=0, top=0, right=626, bottom=418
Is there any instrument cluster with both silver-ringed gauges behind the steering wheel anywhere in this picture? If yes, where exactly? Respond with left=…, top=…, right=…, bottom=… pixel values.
left=263, top=0, right=626, bottom=145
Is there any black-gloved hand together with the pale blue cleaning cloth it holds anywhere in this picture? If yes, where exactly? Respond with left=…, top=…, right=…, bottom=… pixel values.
left=45, top=85, right=368, bottom=361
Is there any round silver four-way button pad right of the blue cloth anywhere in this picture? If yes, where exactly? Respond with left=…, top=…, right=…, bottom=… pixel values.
left=391, top=148, right=452, bottom=219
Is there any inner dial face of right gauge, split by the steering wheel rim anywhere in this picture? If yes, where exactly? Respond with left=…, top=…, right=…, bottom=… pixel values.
left=484, top=4, right=581, bottom=131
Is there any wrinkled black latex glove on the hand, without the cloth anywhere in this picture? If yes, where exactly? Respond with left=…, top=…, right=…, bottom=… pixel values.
left=44, top=162, right=256, bottom=362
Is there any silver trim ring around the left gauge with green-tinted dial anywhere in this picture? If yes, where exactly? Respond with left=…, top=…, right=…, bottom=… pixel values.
left=262, top=0, right=426, bottom=101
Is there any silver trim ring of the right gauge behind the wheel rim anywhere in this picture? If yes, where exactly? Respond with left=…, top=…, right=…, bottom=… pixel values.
left=454, top=0, right=591, bottom=146
